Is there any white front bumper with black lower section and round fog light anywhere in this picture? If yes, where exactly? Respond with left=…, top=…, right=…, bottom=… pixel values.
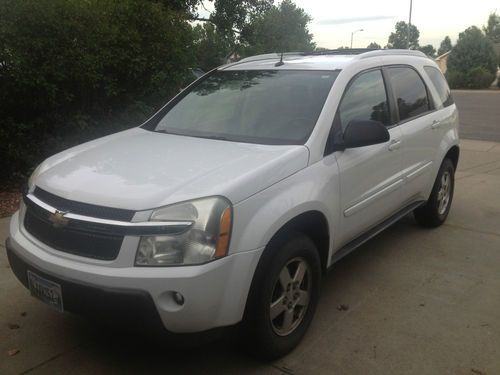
left=7, top=213, right=263, bottom=333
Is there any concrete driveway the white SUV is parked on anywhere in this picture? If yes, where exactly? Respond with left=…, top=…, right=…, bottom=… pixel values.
left=0, top=141, right=500, bottom=375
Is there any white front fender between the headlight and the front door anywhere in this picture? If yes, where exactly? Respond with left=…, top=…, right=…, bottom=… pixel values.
left=230, top=155, right=339, bottom=268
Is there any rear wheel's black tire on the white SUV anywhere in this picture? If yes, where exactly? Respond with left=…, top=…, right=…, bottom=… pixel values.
left=413, top=159, right=455, bottom=228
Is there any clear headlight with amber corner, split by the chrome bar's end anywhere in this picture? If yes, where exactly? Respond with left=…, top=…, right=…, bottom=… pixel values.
left=135, top=197, right=232, bottom=266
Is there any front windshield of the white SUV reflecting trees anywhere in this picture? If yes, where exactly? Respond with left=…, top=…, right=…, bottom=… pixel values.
left=149, top=70, right=338, bottom=144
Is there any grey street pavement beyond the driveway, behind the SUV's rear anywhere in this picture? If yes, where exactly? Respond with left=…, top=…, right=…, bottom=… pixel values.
left=453, top=90, right=500, bottom=142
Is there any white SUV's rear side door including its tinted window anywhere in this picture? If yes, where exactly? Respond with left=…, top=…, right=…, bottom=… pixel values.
left=384, top=66, right=441, bottom=203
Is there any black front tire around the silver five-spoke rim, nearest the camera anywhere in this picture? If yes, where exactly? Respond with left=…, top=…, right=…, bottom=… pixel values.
left=244, top=233, right=321, bottom=360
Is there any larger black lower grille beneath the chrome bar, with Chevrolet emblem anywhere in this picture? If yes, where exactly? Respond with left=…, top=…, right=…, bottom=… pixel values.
left=24, top=189, right=124, bottom=260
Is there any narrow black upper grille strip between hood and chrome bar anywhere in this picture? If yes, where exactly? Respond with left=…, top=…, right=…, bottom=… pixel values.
left=33, top=186, right=135, bottom=221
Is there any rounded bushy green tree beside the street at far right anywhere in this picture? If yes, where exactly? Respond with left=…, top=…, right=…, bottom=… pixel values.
left=446, top=26, right=497, bottom=88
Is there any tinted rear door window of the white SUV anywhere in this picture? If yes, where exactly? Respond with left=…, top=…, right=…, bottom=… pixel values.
left=387, top=67, right=429, bottom=121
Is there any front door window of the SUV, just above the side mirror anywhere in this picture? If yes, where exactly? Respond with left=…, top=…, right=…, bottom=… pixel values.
left=337, top=70, right=390, bottom=130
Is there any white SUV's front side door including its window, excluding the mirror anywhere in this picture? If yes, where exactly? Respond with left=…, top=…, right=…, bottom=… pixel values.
left=334, top=69, right=403, bottom=246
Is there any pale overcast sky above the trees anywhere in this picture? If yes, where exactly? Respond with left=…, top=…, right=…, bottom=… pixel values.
left=198, top=0, right=500, bottom=49
